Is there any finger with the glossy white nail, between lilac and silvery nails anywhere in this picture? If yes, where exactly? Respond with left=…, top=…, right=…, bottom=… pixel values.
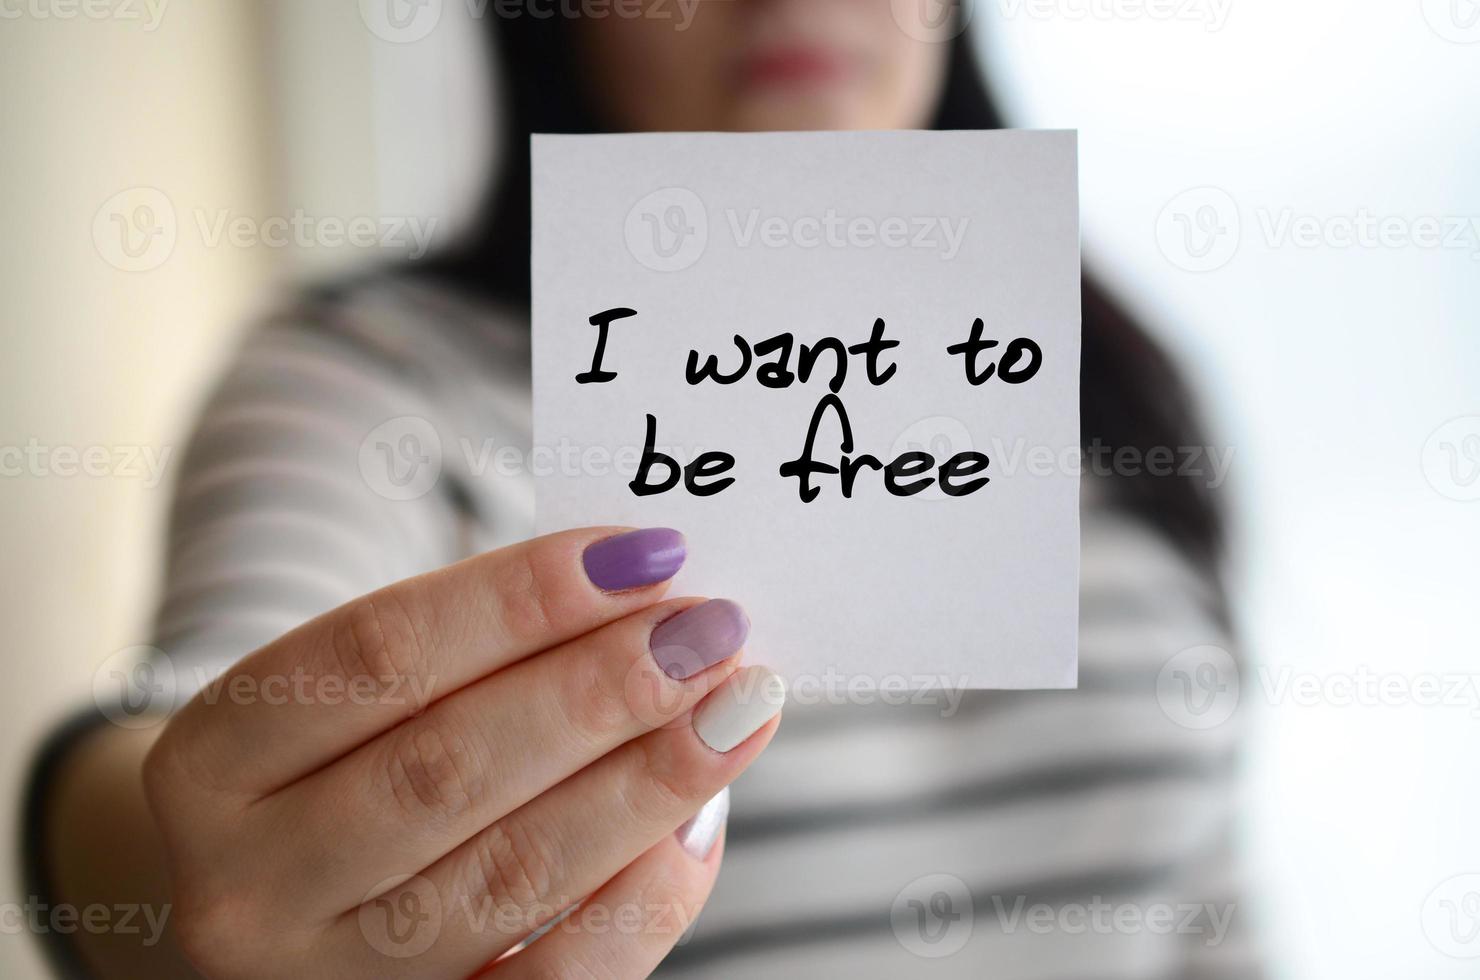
left=334, top=668, right=786, bottom=977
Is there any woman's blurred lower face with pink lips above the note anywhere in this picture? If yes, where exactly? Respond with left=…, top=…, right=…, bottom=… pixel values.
left=577, top=0, right=949, bottom=130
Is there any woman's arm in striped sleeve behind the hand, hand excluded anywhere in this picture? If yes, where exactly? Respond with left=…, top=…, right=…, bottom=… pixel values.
left=27, top=309, right=459, bottom=977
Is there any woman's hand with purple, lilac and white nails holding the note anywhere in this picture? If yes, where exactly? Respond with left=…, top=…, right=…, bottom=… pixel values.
left=145, top=528, right=784, bottom=977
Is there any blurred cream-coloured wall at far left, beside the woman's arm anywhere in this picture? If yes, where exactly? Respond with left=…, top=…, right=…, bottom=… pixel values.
left=0, top=1, right=271, bottom=977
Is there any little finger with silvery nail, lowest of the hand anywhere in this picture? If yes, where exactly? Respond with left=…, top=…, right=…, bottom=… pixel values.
left=480, top=828, right=724, bottom=980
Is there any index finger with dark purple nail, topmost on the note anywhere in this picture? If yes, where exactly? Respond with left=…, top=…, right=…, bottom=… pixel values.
left=154, top=527, right=684, bottom=798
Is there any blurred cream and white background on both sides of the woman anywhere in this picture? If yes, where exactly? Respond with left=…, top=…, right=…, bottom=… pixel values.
left=0, top=0, right=1480, bottom=980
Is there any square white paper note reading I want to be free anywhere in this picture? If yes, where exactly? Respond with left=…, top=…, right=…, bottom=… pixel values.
left=531, top=130, right=1080, bottom=691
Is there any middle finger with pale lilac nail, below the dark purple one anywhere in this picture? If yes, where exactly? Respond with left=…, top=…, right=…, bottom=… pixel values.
left=252, top=600, right=749, bottom=912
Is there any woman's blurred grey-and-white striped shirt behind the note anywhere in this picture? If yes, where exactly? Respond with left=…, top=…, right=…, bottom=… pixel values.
left=157, top=272, right=1257, bottom=980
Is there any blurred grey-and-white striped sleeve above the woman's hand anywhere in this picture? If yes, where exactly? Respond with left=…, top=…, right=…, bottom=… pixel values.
left=154, top=307, right=466, bottom=705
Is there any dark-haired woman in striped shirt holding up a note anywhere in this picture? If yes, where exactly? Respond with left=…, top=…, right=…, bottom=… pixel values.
left=30, top=0, right=1254, bottom=977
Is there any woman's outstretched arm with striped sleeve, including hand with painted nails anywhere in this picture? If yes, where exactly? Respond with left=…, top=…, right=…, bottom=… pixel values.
left=31, top=303, right=784, bottom=979
